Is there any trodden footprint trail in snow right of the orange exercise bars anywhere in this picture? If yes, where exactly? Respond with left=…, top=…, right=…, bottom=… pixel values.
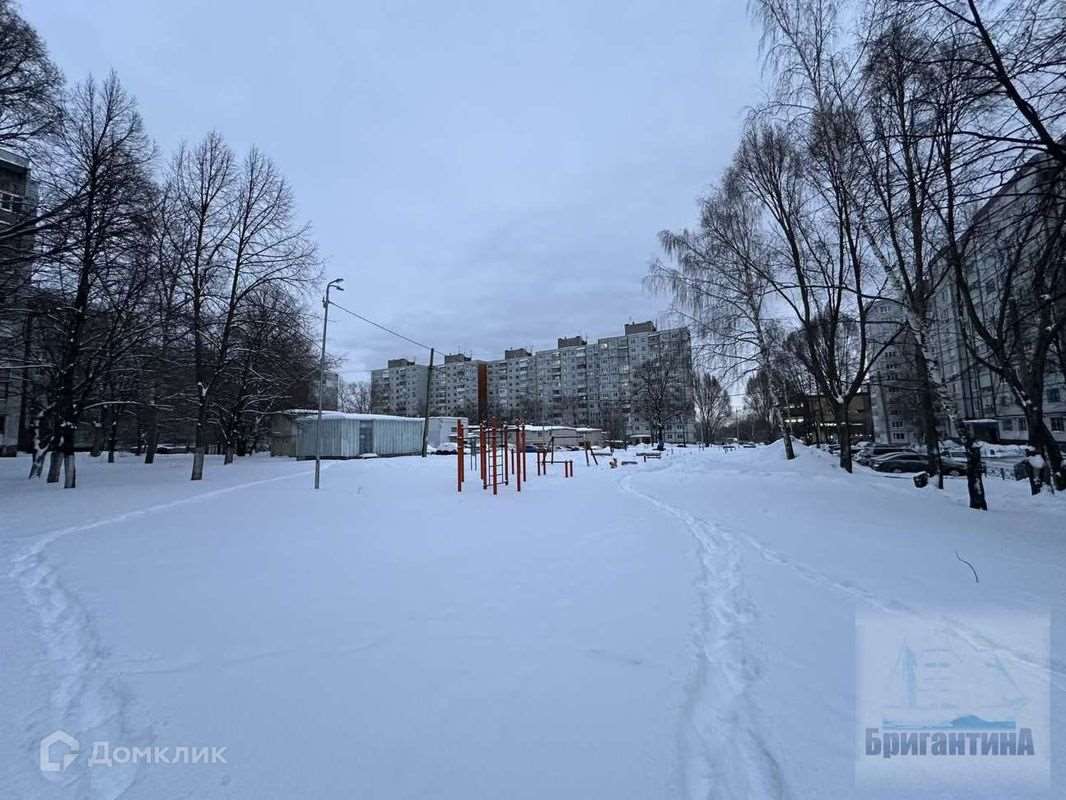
left=618, top=459, right=788, bottom=800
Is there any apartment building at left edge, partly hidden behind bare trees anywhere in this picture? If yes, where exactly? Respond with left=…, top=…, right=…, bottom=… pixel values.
left=0, top=150, right=35, bottom=455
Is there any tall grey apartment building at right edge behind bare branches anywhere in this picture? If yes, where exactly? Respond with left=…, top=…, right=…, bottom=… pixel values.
left=930, top=153, right=1066, bottom=444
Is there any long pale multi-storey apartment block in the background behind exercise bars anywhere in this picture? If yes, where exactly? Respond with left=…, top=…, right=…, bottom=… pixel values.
left=371, top=322, right=695, bottom=442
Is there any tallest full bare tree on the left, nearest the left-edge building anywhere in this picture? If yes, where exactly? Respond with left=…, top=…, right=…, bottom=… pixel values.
left=34, top=74, right=155, bottom=489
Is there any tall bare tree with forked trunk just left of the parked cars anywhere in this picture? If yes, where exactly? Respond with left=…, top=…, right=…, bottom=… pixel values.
left=750, top=0, right=899, bottom=471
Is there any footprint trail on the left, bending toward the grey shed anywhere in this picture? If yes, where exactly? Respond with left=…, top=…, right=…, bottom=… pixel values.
left=9, top=465, right=319, bottom=800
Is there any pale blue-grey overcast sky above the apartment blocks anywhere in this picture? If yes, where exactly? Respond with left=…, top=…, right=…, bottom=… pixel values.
left=29, top=0, right=760, bottom=380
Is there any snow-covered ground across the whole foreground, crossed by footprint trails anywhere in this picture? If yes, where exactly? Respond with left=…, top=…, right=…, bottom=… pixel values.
left=0, top=447, right=1066, bottom=800
